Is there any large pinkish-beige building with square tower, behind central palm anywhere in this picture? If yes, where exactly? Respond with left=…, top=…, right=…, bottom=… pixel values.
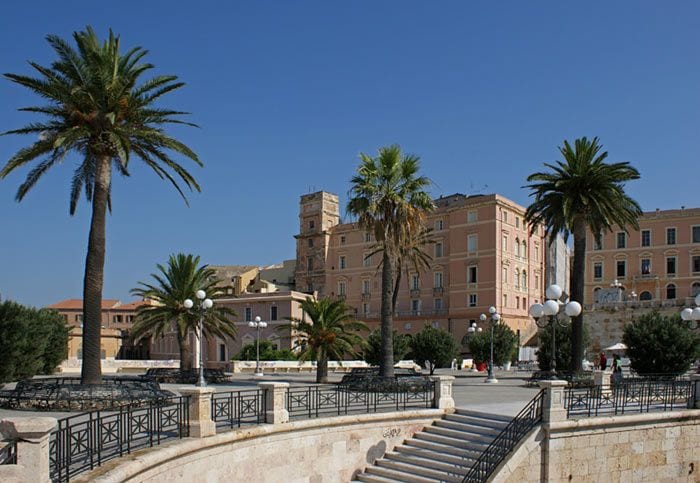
left=295, top=192, right=546, bottom=351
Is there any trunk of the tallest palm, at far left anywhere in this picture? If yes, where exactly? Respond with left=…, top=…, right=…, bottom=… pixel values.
left=81, top=156, right=112, bottom=384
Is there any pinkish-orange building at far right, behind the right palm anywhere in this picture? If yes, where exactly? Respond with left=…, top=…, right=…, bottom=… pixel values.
left=585, top=208, right=700, bottom=305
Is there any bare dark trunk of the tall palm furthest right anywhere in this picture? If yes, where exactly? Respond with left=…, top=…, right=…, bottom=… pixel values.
left=572, top=218, right=586, bottom=372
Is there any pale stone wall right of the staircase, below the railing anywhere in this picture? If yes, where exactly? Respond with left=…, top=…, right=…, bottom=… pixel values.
left=491, top=409, right=700, bottom=483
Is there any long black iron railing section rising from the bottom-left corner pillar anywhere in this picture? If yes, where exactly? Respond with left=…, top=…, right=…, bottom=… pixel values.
left=49, top=397, right=190, bottom=482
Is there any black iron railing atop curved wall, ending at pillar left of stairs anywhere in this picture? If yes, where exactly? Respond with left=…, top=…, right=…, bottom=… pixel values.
left=287, top=378, right=435, bottom=419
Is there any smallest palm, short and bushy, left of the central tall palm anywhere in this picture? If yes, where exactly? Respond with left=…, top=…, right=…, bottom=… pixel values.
left=278, top=297, right=367, bottom=383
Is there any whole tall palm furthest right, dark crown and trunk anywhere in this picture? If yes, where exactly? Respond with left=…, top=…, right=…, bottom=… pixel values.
left=525, top=137, right=642, bottom=371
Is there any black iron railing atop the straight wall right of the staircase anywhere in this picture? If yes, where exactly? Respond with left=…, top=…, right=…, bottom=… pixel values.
left=564, top=379, right=694, bottom=417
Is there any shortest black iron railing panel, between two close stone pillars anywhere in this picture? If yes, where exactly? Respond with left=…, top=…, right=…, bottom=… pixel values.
left=211, top=389, right=266, bottom=428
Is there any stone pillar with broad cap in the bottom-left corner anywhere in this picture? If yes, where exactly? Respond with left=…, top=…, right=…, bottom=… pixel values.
left=0, top=418, right=58, bottom=483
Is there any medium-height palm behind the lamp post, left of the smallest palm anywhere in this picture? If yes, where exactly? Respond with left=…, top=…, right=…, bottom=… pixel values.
left=131, top=253, right=237, bottom=370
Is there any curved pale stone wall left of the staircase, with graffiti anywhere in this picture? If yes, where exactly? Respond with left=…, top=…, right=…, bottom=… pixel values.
left=73, top=409, right=443, bottom=483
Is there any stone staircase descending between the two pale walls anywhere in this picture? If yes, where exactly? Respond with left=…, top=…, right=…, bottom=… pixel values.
left=353, top=409, right=511, bottom=483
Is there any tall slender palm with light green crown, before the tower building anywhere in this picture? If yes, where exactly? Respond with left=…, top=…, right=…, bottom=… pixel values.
left=347, top=145, right=434, bottom=377
